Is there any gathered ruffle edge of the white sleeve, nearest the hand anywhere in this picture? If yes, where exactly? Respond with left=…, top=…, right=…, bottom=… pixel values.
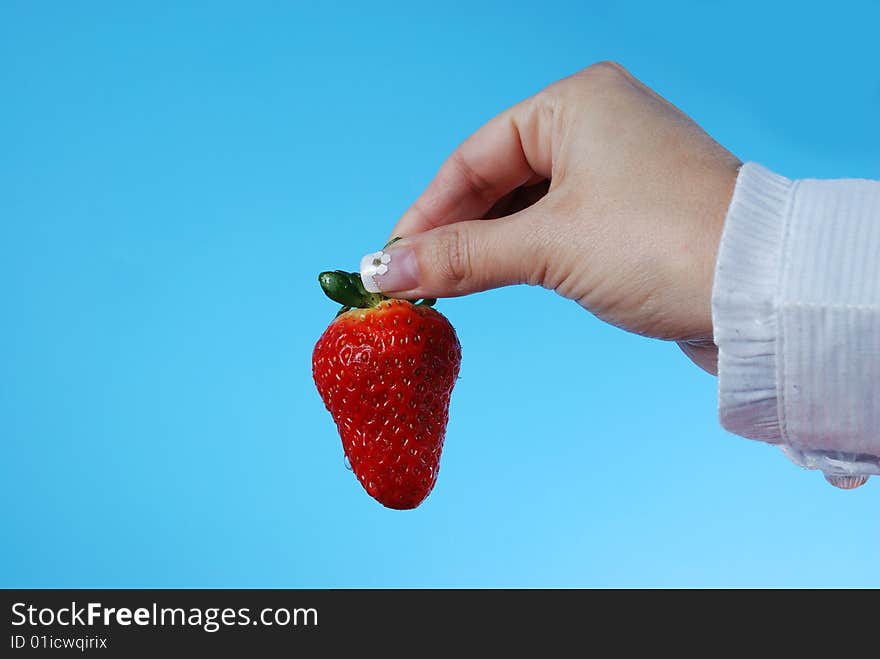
left=712, top=163, right=796, bottom=443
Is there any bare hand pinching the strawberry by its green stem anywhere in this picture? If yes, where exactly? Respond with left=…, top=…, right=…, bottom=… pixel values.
left=362, top=63, right=741, bottom=372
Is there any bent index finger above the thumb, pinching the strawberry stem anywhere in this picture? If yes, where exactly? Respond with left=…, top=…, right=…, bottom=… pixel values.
left=391, top=97, right=552, bottom=241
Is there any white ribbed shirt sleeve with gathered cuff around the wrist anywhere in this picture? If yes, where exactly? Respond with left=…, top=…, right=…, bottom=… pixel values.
left=712, top=163, right=880, bottom=487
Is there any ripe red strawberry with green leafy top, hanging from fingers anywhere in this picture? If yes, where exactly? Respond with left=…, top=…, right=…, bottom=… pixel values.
left=312, top=270, right=461, bottom=510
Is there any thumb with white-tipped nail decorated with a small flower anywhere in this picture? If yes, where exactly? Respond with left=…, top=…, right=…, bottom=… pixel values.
left=361, top=210, right=547, bottom=299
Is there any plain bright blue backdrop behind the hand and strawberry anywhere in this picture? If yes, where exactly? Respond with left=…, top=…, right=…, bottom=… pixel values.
left=0, top=1, right=880, bottom=587
